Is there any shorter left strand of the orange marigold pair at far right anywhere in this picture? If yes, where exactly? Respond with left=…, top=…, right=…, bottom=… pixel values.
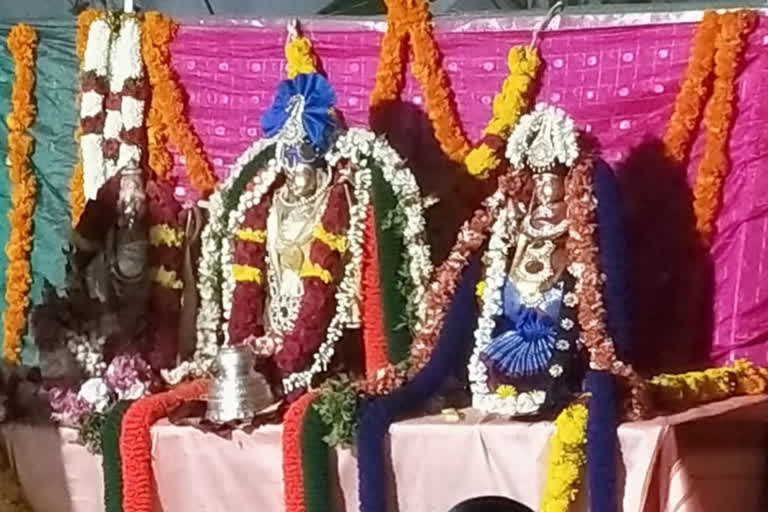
left=664, top=11, right=720, bottom=164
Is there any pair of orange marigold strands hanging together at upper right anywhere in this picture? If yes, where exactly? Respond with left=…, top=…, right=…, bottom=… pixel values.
left=664, top=10, right=757, bottom=241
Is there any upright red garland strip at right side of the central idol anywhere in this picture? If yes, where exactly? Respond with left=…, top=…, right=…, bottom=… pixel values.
left=361, top=206, right=389, bottom=377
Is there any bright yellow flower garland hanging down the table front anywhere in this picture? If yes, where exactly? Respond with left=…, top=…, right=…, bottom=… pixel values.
left=539, top=403, right=587, bottom=512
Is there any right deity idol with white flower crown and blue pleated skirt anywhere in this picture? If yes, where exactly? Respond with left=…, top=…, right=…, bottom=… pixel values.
left=469, top=105, right=641, bottom=416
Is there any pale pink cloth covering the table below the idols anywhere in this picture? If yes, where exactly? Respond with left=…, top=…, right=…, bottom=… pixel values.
left=2, top=396, right=768, bottom=512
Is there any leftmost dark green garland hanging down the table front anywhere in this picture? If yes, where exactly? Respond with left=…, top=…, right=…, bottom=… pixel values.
left=101, top=401, right=132, bottom=512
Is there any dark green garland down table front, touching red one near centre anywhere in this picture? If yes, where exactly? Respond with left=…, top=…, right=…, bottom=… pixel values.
left=301, top=403, right=331, bottom=512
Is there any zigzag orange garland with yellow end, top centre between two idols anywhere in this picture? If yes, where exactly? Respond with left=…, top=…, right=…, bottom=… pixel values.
left=370, top=0, right=541, bottom=177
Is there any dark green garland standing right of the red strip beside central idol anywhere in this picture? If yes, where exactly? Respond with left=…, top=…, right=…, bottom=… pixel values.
left=371, top=165, right=411, bottom=364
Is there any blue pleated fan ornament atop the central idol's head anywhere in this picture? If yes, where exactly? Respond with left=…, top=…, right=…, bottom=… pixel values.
left=261, top=73, right=336, bottom=153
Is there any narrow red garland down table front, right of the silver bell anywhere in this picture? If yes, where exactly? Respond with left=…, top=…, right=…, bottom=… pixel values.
left=284, top=393, right=317, bottom=512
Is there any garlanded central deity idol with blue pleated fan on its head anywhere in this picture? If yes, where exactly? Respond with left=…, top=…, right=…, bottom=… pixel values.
left=165, top=68, right=431, bottom=404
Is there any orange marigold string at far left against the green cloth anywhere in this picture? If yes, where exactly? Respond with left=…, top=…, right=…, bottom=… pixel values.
left=3, top=24, right=37, bottom=364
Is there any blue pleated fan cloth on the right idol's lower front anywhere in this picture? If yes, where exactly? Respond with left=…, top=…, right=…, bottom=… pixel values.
left=483, top=306, right=557, bottom=377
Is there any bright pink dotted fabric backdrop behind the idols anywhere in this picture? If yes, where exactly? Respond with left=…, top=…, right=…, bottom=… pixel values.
left=165, top=16, right=768, bottom=364
